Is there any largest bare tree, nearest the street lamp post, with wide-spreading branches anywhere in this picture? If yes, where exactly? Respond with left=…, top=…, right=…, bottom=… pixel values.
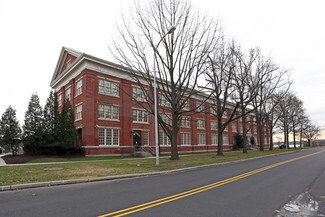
left=112, top=0, right=220, bottom=160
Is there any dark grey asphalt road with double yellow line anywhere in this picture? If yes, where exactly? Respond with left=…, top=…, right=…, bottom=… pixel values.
left=0, top=149, right=325, bottom=217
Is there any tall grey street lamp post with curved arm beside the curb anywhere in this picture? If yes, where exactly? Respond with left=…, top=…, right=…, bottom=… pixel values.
left=154, top=26, right=176, bottom=166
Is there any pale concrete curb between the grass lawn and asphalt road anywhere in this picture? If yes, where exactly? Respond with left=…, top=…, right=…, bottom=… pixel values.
left=0, top=151, right=299, bottom=192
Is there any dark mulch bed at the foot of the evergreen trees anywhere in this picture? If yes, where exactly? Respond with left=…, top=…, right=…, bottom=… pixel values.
left=2, top=154, right=83, bottom=164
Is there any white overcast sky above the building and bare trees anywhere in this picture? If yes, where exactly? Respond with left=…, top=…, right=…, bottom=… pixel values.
left=0, top=0, right=325, bottom=137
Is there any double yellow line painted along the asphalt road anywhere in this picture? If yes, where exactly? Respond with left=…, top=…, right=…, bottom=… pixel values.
left=98, top=150, right=325, bottom=217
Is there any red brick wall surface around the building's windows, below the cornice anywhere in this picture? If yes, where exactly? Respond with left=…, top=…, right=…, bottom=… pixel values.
left=54, top=69, right=270, bottom=156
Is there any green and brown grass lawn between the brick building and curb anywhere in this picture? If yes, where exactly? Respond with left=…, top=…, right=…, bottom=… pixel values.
left=0, top=148, right=301, bottom=186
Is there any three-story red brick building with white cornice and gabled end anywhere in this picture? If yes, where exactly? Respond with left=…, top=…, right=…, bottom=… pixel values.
left=51, top=47, right=269, bottom=156
